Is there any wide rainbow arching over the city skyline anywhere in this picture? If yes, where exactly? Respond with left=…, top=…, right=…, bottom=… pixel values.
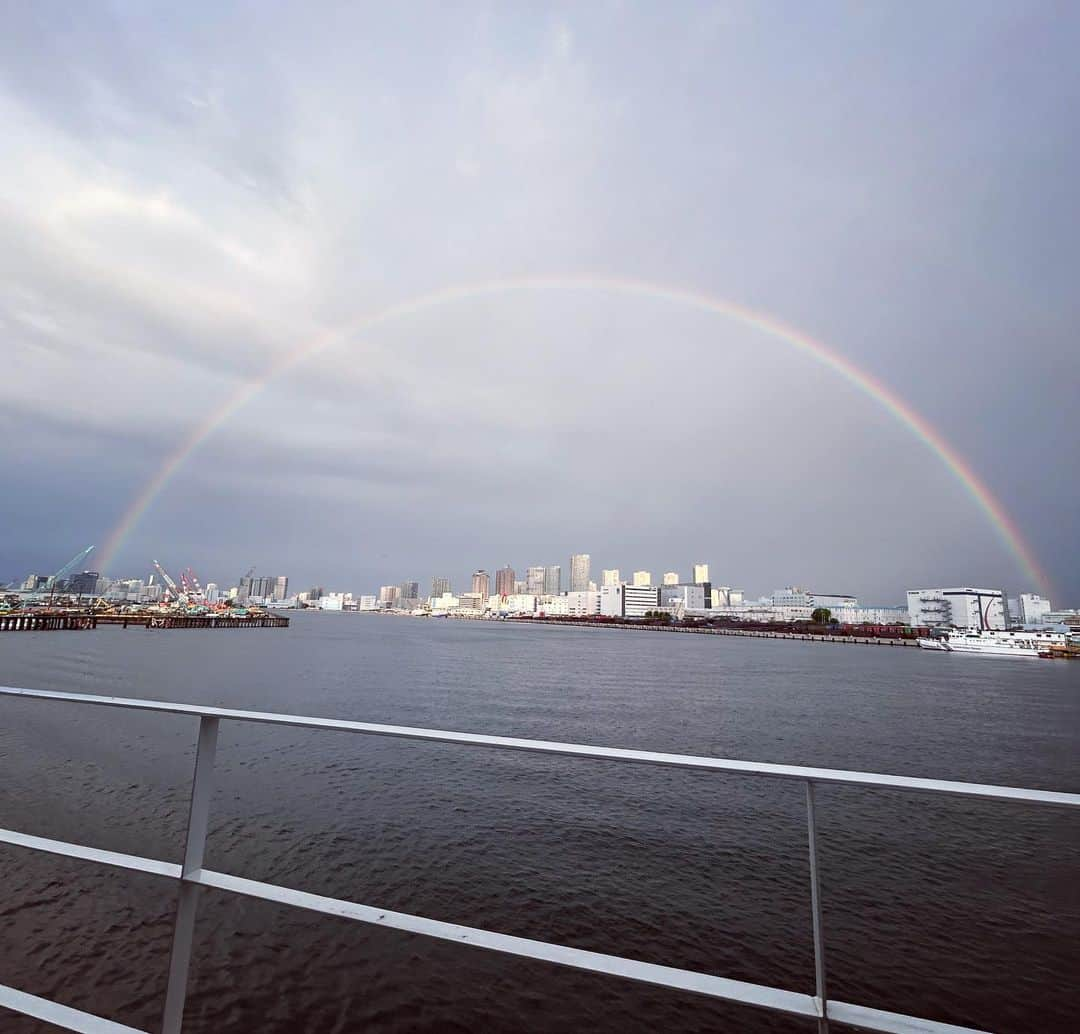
left=98, top=276, right=1050, bottom=595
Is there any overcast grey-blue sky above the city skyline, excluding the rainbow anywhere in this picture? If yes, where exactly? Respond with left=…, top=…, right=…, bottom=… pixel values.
left=0, top=0, right=1080, bottom=605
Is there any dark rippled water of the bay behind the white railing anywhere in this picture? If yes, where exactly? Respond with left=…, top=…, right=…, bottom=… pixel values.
left=0, top=615, right=1080, bottom=1034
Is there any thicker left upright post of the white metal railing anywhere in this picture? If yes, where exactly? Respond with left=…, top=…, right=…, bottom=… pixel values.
left=161, top=716, right=218, bottom=1034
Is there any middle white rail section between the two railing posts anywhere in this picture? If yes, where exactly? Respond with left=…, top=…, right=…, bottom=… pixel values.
left=194, top=869, right=821, bottom=1018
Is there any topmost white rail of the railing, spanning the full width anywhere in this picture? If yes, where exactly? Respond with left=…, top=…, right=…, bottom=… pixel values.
left=0, top=686, right=1080, bottom=808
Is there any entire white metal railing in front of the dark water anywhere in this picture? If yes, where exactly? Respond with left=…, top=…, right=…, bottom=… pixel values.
left=0, top=686, right=1080, bottom=1034
